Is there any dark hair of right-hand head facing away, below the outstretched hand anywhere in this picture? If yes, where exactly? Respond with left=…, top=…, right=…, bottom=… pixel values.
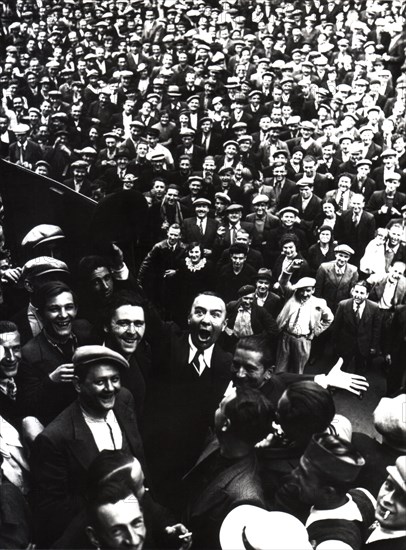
left=278, top=380, right=335, bottom=446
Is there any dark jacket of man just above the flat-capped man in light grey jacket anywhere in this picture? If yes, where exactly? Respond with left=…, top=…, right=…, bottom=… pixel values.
left=336, top=208, right=375, bottom=262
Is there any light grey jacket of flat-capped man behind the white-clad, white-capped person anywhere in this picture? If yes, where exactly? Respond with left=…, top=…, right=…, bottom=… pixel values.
left=315, top=260, right=358, bottom=313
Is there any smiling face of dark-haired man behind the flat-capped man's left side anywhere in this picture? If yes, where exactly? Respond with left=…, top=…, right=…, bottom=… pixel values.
left=41, top=292, right=77, bottom=341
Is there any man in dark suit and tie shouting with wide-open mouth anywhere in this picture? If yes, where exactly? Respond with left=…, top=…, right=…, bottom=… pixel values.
left=144, top=292, right=232, bottom=504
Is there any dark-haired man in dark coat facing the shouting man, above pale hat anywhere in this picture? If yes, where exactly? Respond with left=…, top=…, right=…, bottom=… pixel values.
left=183, top=388, right=271, bottom=549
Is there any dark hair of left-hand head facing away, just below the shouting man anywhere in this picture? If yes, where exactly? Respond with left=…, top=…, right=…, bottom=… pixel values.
left=224, top=388, right=275, bottom=445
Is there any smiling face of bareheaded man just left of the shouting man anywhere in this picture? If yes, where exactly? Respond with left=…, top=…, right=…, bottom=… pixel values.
left=105, top=305, right=145, bottom=357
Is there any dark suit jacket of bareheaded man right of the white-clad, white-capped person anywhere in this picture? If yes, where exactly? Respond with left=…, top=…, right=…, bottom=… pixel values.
left=333, top=298, right=381, bottom=359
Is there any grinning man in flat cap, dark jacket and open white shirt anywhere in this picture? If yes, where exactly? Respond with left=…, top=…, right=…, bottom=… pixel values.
left=31, top=346, right=145, bottom=545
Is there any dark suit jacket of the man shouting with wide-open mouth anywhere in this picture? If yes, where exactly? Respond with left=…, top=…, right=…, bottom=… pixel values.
left=144, top=320, right=232, bottom=498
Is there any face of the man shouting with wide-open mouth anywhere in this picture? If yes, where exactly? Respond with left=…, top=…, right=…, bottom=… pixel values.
left=188, top=294, right=226, bottom=349
